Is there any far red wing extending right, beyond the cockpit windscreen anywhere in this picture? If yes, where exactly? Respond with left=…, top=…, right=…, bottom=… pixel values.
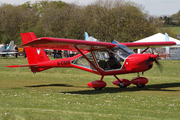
left=119, top=41, right=176, bottom=49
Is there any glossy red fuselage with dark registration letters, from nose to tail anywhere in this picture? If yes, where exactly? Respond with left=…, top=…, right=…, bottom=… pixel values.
left=37, top=52, right=157, bottom=75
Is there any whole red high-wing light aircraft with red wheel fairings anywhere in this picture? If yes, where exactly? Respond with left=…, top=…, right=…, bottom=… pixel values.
left=6, top=32, right=176, bottom=90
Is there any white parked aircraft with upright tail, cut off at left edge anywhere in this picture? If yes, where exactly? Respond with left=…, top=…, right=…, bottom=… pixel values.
left=0, top=41, right=18, bottom=56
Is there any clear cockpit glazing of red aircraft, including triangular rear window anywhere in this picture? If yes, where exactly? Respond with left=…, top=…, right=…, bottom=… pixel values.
left=72, top=44, right=134, bottom=71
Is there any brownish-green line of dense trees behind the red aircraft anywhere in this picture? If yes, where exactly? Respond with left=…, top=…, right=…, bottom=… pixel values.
left=0, top=0, right=177, bottom=45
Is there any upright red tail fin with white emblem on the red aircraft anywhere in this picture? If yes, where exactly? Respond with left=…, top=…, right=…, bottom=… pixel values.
left=21, top=32, right=50, bottom=72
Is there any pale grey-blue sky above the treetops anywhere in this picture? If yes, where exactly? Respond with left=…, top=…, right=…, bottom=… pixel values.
left=0, top=0, right=180, bottom=16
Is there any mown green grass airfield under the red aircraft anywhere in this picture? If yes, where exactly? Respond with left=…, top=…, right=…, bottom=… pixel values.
left=0, top=57, right=180, bottom=120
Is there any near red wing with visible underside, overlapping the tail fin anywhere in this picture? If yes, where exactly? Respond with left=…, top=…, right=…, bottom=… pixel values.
left=21, top=37, right=116, bottom=51
